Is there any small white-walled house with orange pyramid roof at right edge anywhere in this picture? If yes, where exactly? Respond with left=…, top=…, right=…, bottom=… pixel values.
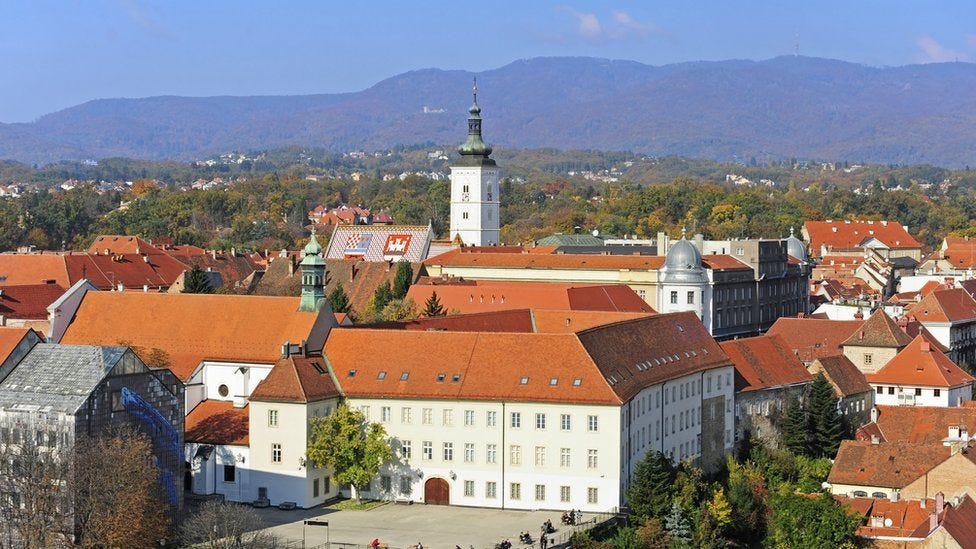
left=865, top=335, right=974, bottom=406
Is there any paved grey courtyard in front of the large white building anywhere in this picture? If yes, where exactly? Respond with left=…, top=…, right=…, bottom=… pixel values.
left=256, top=503, right=593, bottom=549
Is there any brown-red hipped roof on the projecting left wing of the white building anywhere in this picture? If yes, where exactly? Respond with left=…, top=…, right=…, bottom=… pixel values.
left=248, top=356, right=339, bottom=404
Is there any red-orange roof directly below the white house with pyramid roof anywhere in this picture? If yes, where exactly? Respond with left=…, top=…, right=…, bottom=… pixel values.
left=855, top=406, right=976, bottom=443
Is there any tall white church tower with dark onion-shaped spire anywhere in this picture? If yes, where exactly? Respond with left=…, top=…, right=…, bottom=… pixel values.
left=449, top=81, right=499, bottom=246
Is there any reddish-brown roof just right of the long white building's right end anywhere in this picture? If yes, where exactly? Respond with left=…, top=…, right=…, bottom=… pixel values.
left=721, top=335, right=812, bottom=392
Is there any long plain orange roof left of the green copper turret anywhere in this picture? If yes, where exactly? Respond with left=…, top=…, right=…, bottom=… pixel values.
left=61, top=292, right=318, bottom=380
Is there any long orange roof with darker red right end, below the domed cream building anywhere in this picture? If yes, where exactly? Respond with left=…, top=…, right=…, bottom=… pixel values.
left=407, top=281, right=654, bottom=313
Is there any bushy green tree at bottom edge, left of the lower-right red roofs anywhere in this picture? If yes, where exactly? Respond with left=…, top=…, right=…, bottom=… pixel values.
left=767, top=493, right=861, bottom=549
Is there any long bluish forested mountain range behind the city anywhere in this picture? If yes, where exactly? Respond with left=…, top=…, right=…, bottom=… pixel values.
left=0, top=57, right=976, bottom=167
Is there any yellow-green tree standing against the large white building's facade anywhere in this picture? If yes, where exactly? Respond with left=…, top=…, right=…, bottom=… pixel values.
left=306, top=404, right=392, bottom=501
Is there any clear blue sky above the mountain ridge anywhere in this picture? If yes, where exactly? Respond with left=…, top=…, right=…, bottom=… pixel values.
left=0, top=0, right=976, bottom=122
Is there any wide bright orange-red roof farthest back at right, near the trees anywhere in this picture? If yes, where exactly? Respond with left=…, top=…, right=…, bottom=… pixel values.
left=803, top=221, right=922, bottom=255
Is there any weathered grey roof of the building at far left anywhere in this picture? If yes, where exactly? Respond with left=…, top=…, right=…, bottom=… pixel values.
left=0, top=343, right=128, bottom=414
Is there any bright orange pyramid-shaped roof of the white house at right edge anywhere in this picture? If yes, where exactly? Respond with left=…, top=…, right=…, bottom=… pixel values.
left=866, top=336, right=974, bottom=388
